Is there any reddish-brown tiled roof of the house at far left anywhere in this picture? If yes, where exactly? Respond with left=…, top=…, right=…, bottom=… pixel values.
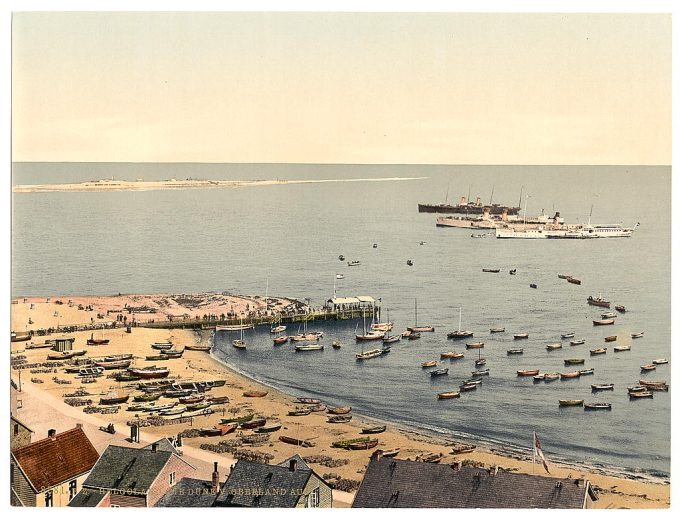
left=12, top=428, right=99, bottom=491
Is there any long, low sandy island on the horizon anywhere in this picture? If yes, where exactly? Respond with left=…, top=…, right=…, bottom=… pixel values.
left=12, top=177, right=427, bottom=193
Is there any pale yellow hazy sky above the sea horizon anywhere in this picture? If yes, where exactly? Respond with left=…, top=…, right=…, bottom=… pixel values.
left=12, top=12, right=672, bottom=164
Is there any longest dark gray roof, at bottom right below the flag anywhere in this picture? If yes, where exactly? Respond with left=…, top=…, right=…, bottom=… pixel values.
left=352, top=458, right=587, bottom=509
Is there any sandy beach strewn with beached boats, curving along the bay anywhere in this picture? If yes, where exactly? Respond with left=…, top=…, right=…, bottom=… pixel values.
left=11, top=295, right=670, bottom=508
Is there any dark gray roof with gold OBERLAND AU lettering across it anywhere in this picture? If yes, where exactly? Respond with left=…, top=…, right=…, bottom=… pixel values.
left=215, top=460, right=312, bottom=507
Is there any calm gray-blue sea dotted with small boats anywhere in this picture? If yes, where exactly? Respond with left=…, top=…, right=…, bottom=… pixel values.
left=11, top=163, right=671, bottom=477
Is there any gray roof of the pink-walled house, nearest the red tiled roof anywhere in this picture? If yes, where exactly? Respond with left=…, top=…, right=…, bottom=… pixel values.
left=83, top=446, right=174, bottom=494
